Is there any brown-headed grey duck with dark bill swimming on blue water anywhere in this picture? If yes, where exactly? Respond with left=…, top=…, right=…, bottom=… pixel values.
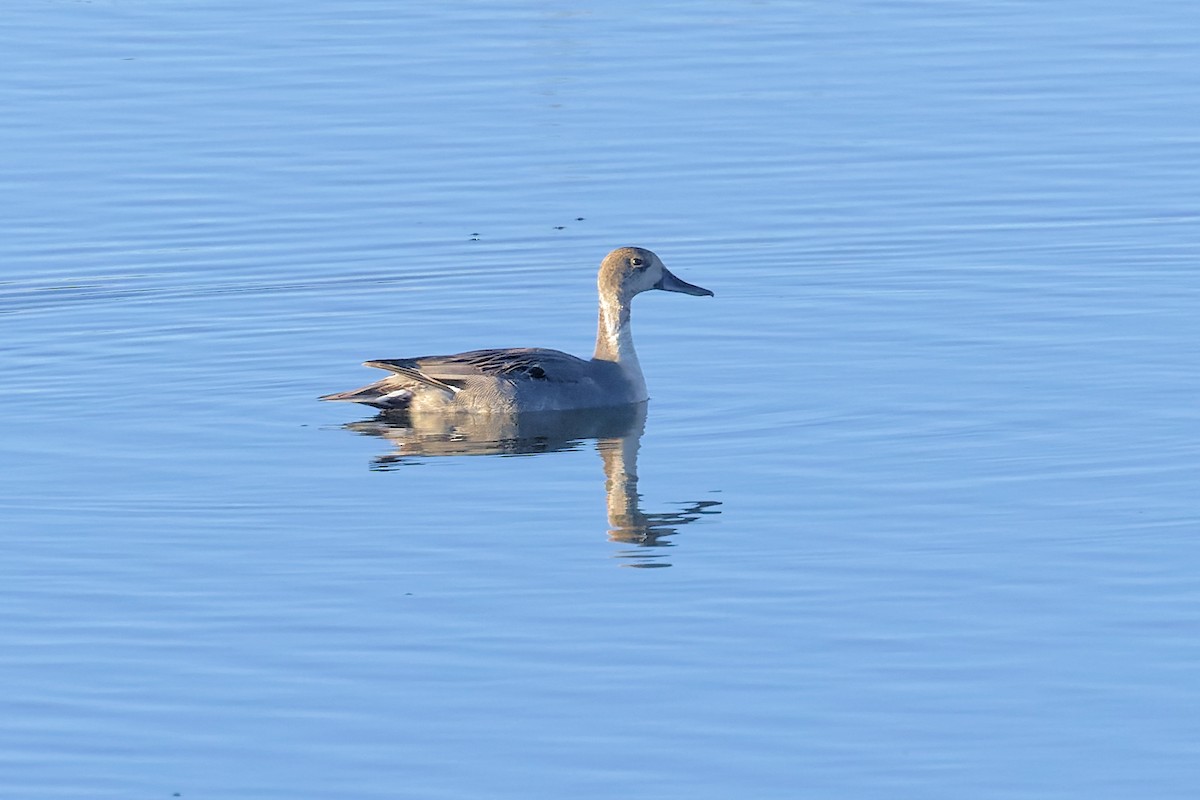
left=320, top=247, right=713, bottom=414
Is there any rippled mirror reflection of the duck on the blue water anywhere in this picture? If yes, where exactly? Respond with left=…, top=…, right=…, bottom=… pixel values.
left=344, top=403, right=720, bottom=567
